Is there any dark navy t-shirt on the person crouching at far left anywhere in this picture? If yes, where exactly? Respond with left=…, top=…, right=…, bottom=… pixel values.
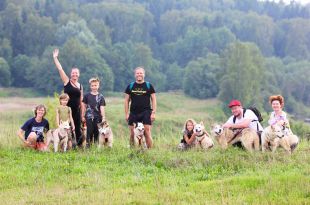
left=21, top=117, right=49, bottom=142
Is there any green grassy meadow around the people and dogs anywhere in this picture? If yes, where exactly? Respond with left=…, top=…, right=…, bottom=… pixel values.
left=0, top=93, right=310, bottom=204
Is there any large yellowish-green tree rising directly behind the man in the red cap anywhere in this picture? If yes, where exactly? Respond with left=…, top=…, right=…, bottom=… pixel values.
left=219, top=42, right=265, bottom=109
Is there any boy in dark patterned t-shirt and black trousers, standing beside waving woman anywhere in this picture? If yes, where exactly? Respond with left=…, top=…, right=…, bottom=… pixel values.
left=82, top=78, right=106, bottom=147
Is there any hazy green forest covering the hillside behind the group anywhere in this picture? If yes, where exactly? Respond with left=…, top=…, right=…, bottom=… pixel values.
left=0, top=0, right=310, bottom=117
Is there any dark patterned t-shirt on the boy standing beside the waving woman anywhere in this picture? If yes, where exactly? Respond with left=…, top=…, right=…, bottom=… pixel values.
left=83, top=93, right=105, bottom=119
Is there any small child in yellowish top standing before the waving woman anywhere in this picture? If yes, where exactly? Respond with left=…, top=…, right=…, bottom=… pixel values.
left=56, top=93, right=75, bottom=149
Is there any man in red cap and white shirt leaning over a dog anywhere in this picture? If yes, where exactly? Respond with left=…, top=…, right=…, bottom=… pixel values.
left=223, top=100, right=263, bottom=134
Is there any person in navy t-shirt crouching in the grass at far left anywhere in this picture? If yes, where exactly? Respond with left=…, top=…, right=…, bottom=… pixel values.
left=17, top=105, right=49, bottom=151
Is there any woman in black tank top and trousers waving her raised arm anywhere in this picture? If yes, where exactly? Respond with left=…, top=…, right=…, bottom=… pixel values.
left=53, top=49, right=83, bottom=146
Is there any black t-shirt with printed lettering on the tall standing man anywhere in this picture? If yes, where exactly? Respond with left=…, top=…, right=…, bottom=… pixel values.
left=125, top=82, right=155, bottom=114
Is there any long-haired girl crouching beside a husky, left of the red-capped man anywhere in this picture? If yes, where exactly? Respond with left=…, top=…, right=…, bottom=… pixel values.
left=178, top=119, right=196, bottom=150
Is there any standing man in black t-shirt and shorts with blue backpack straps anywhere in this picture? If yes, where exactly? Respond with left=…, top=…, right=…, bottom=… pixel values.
left=125, top=67, right=156, bottom=148
